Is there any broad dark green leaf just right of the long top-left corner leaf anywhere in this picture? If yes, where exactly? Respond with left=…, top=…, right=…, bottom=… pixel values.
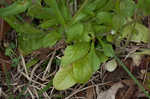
left=27, top=4, right=54, bottom=19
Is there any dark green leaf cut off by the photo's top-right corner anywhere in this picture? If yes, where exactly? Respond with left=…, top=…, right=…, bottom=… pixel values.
left=137, top=0, right=150, bottom=15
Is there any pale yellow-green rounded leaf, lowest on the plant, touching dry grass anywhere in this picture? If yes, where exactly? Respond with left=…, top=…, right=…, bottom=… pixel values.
left=53, top=65, right=76, bottom=90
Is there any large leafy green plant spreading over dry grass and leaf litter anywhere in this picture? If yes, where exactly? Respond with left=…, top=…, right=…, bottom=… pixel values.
left=0, top=0, right=150, bottom=93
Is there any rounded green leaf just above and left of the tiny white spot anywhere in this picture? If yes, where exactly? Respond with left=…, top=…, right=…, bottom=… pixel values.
left=96, top=12, right=112, bottom=25
